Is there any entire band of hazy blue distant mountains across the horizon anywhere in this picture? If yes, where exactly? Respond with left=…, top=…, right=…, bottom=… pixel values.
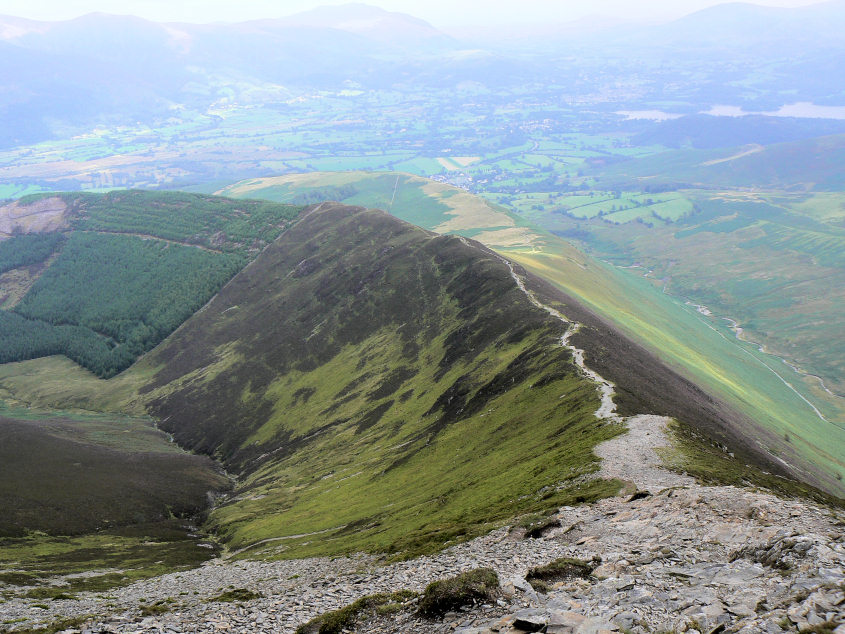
left=0, top=0, right=845, bottom=148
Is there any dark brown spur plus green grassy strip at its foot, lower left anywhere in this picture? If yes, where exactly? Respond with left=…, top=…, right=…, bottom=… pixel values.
left=0, top=402, right=228, bottom=600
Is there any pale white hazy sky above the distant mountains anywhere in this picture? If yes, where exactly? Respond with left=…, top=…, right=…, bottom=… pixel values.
left=0, top=0, right=818, bottom=28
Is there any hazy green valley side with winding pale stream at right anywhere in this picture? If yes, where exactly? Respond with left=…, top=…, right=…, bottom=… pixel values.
left=538, top=191, right=845, bottom=396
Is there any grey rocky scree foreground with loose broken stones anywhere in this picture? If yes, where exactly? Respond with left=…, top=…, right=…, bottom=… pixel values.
left=0, top=416, right=845, bottom=634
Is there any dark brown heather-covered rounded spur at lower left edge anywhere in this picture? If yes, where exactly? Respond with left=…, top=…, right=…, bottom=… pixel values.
left=0, top=414, right=227, bottom=538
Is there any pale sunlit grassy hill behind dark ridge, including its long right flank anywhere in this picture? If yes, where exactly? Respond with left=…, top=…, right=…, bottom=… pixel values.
left=219, top=173, right=845, bottom=494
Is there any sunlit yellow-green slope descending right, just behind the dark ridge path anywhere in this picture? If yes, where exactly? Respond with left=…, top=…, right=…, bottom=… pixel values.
left=504, top=239, right=845, bottom=490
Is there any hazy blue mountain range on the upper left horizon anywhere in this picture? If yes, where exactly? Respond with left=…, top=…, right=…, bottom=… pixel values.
left=0, top=5, right=468, bottom=148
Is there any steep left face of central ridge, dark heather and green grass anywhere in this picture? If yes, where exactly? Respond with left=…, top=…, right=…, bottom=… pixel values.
left=134, top=206, right=619, bottom=556
